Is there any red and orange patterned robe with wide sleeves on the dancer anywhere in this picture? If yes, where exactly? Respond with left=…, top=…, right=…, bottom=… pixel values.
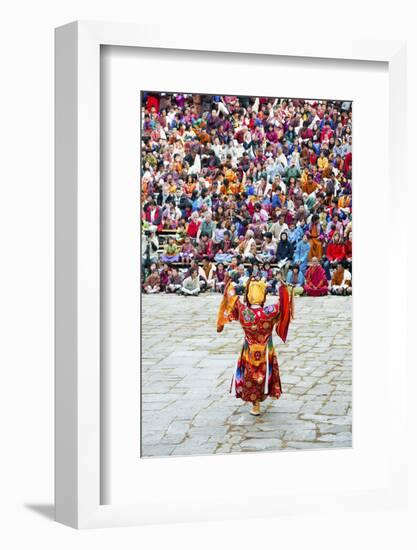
left=217, top=282, right=292, bottom=402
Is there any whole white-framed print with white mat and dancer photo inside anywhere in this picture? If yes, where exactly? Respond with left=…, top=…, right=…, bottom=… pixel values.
left=56, top=22, right=407, bottom=527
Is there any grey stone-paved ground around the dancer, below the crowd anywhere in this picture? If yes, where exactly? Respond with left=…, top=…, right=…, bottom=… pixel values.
left=142, top=294, right=352, bottom=457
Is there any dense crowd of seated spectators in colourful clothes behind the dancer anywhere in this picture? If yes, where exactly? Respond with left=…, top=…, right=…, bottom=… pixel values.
left=141, top=92, right=352, bottom=296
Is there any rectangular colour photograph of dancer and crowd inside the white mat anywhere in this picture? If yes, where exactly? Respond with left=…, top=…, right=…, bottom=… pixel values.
left=138, top=90, right=353, bottom=458
